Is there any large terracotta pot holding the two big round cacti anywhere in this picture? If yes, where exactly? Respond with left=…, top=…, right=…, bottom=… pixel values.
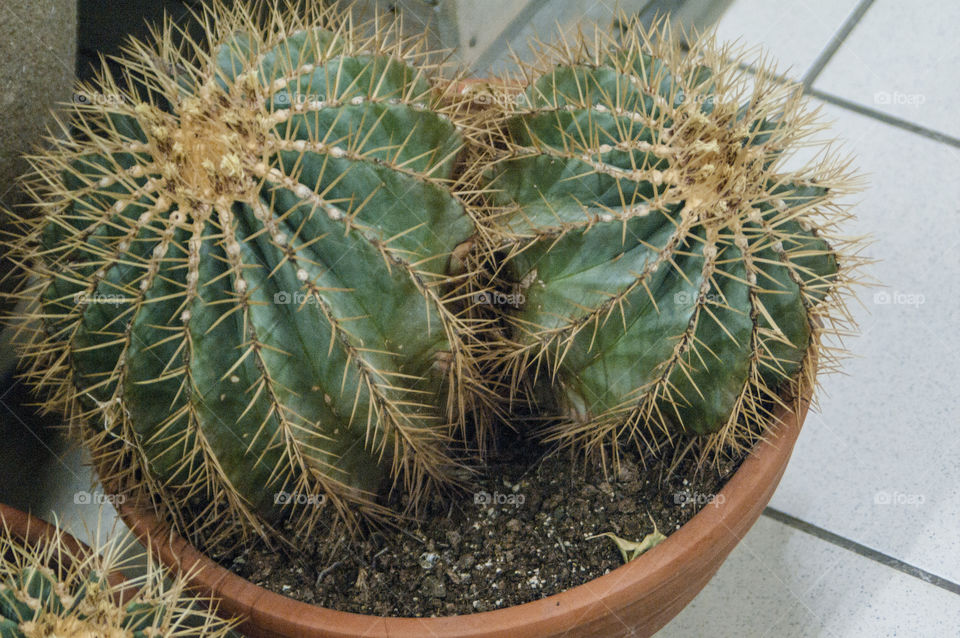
left=120, top=400, right=809, bottom=638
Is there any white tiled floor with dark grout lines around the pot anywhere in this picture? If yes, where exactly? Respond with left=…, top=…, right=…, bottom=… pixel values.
left=0, top=0, right=960, bottom=638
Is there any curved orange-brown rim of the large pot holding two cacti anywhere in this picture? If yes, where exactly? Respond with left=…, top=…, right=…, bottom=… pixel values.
left=120, top=395, right=810, bottom=638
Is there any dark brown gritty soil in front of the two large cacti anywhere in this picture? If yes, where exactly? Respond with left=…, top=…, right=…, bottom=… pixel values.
left=219, top=442, right=739, bottom=616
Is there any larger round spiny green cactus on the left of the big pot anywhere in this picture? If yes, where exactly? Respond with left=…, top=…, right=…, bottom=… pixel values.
left=14, top=3, right=496, bottom=547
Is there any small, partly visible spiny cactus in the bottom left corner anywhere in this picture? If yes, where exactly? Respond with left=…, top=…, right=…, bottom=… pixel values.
left=0, top=525, right=235, bottom=638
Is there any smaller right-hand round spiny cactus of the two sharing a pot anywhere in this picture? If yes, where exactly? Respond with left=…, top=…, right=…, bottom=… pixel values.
left=487, top=19, right=858, bottom=460
